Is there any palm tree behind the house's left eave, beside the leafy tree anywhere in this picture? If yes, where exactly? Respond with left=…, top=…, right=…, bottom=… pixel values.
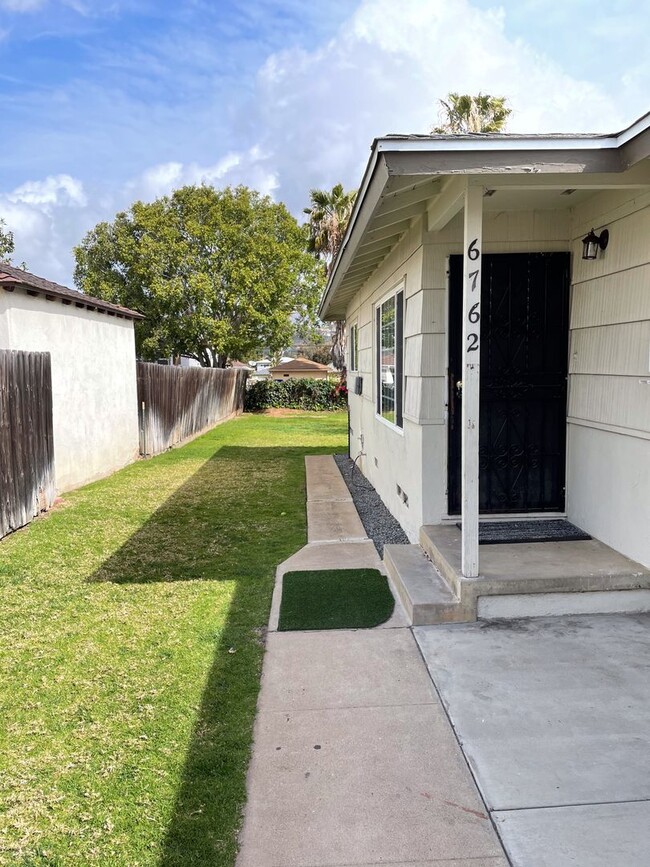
left=304, top=184, right=357, bottom=370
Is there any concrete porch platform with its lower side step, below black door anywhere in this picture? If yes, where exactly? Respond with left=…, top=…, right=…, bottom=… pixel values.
left=384, top=525, right=650, bottom=626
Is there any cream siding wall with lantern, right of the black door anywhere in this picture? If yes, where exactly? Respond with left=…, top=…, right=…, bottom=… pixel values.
left=567, top=191, right=650, bottom=566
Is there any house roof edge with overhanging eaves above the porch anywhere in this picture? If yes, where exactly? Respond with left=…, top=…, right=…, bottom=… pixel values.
left=319, top=112, right=650, bottom=320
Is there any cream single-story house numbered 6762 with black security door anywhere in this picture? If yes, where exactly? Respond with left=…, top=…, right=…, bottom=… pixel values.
left=320, top=114, right=650, bottom=622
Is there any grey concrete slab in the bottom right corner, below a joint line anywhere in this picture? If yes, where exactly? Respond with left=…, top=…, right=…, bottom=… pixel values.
left=493, top=801, right=650, bottom=867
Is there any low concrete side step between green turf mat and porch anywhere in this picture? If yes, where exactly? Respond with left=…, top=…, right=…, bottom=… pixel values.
left=384, top=545, right=476, bottom=626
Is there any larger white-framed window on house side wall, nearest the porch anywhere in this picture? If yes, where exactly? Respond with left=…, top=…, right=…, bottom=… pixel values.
left=375, top=290, right=404, bottom=428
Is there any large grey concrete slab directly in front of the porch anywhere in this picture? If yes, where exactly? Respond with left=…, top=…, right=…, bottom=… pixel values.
left=414, top=615, right=650, bottom=812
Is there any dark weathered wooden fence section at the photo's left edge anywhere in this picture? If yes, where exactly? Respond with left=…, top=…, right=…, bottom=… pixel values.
left=0, top=349, right=55, bottom=538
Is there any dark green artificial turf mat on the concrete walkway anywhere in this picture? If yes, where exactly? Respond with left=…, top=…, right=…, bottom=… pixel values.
left=278, top=569, right=395, bottom=632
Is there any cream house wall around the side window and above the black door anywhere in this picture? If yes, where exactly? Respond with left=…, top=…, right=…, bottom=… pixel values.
left=346, top=210, right=571, bottom=541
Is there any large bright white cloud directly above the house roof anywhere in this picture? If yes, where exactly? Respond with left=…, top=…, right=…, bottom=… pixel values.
left=244, top=0, right=630, bottom=210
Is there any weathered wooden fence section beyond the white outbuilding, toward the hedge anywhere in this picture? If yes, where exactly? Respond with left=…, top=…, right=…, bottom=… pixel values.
left=138, top=361, right=247, bottom=456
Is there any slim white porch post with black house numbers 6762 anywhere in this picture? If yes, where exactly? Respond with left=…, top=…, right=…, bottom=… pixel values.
left=461, top=178, right=483, bottom=578
